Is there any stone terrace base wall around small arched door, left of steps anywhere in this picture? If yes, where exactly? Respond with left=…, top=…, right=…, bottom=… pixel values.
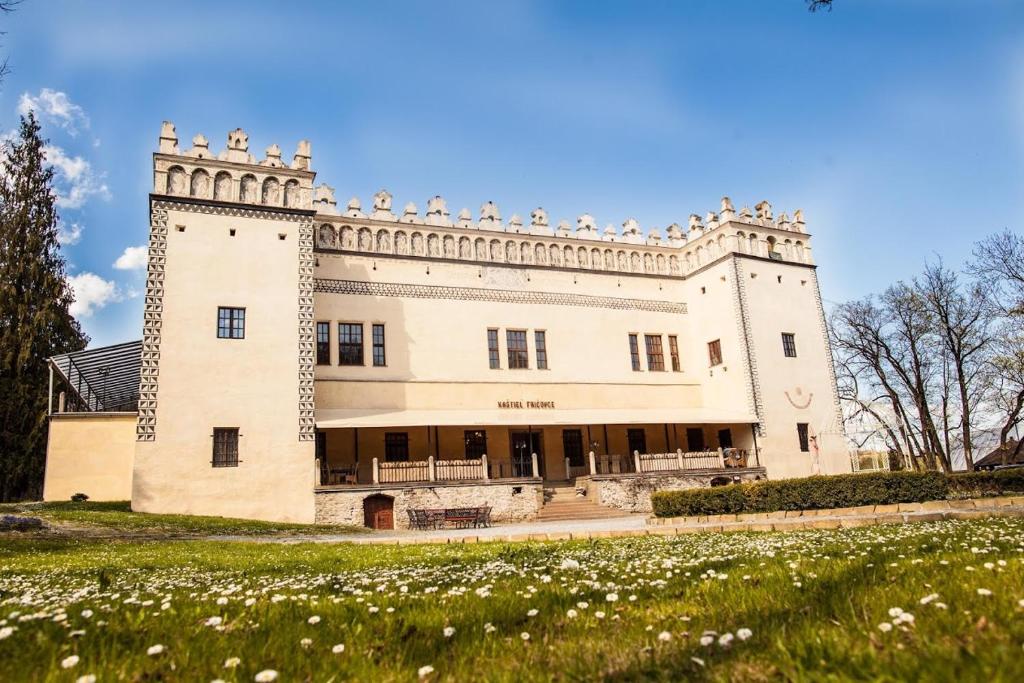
left=314, top=481, right=544, bottom=528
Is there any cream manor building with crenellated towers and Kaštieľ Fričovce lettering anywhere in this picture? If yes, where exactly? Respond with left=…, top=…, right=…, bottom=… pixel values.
left=44, top=123, right=851, bottom=526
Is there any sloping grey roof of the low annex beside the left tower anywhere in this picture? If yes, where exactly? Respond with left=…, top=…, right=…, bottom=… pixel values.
left=50, top=341, right=142, bottom=412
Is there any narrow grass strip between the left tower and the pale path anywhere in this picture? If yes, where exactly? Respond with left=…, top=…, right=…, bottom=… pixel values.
left=0, top=501, right=366, bottom=536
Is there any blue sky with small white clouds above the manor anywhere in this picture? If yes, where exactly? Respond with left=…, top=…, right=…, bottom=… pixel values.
left=0, top=0, right=1024, bottom=345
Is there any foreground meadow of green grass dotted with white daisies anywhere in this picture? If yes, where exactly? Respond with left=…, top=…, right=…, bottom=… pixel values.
left=0, top=518, right=1024, bottom=682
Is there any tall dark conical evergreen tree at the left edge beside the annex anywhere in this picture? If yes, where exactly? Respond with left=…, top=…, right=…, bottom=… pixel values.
left=0, top=112, right=88, bottom=501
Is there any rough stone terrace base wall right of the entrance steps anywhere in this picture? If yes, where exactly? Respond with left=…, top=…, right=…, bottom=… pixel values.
left=577, top=467, right=766, bottom=512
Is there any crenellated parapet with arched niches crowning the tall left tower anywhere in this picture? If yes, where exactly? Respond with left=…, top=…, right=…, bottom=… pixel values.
left=153, top=121, right=311, bottom=209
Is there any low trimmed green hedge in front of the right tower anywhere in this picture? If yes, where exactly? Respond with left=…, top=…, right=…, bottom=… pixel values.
left=651, top=471, right=954, bottom=517
